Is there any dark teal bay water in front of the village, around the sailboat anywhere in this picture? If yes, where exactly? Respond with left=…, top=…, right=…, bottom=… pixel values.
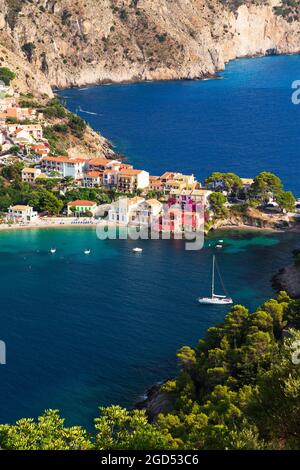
left=0, top=228, right=299, bottom=426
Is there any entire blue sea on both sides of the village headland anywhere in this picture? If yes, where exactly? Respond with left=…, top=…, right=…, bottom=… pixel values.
left=0, top=57, right=300, bottom=428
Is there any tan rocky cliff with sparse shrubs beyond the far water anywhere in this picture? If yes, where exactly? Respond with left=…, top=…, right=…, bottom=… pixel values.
left=0, top=0, right=300, bottom=94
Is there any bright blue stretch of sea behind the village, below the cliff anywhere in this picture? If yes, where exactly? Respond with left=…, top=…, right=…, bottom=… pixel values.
left=61, top=56, right=300, bottom=197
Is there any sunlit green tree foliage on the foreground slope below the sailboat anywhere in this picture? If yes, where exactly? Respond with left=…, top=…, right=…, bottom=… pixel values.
left=0, top=292, right=300, bottom=450
